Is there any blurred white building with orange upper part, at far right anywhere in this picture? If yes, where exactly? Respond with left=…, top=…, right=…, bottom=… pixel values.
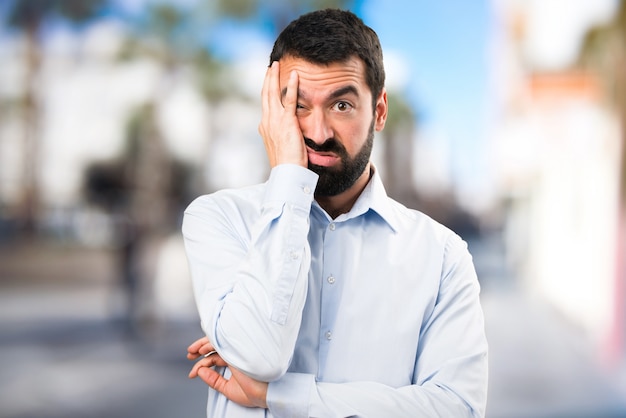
left=492, top=0, right=626, bottom=361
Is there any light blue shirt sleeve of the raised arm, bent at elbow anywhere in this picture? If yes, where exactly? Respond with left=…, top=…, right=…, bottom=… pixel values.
left=182, top=165, right=317, bottom=381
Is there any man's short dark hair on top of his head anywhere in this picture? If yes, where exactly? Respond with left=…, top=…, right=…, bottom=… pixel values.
left=270, top=9, right=385, bottom=104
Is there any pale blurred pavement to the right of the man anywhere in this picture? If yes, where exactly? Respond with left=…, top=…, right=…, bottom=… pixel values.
left=469, top=237, right=626, bottom=418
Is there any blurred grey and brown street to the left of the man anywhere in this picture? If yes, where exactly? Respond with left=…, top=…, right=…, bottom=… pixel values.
left=0, top=238, right=206, bottom=418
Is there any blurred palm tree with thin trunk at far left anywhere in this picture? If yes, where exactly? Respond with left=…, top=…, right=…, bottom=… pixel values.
left=6, top=0, right=107, bottom=236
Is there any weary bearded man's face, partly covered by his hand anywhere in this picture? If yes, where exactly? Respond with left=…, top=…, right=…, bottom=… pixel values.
left=280, top=57, right=386, bottom=197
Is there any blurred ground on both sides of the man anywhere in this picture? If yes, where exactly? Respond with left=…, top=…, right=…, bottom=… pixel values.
left=0, top=235, right=626, bottom=418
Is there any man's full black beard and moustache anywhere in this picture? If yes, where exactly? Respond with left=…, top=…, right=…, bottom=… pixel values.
left=304, top=119, right=374, bottom=197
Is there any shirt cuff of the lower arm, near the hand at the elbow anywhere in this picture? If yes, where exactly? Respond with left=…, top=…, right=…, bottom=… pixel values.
left=266, top=373, right=315, bottom=418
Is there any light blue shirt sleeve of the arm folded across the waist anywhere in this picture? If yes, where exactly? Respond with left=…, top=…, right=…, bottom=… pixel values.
left=267, top=236, right=488, bottom=418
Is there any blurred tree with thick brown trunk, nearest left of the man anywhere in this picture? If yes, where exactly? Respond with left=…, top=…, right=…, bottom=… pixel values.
left=114, top=0, right=254, bottom=236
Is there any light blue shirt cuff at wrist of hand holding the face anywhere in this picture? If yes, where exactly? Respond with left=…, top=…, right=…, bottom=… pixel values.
left=264, top=164, right=319, bottom=210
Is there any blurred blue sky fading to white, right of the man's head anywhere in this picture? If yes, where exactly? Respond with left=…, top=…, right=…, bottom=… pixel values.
left=362, top=0, right=492, bottom=199
